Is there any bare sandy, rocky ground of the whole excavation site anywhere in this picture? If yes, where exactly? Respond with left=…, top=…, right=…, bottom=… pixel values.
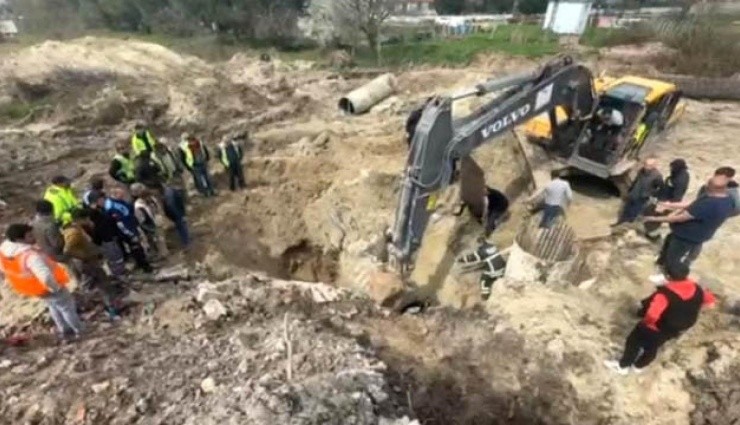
left=0, top=38, right=740, bottom=424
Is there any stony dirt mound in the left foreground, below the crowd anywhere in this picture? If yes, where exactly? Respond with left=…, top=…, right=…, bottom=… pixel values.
left=0, top=276, right=411, bottom=425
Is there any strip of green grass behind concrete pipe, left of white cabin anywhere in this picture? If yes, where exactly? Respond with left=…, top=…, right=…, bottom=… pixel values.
left=357, top=25, right=559, bottom=67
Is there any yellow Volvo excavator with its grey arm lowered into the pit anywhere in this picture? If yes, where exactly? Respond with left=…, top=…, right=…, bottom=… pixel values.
left=389, top=56, right=680, bottom=274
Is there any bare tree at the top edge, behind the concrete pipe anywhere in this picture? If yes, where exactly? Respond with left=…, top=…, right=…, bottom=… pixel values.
left=334, top=0, right=398, bottom=62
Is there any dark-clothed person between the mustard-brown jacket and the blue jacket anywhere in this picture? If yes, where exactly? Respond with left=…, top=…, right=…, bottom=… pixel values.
left=87, top=195, right=126, bottom=282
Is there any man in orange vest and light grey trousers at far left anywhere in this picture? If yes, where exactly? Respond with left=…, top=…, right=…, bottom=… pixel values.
left=0, top=224, right=83, bottom=338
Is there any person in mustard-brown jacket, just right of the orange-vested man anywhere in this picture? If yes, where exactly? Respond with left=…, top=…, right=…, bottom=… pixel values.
left=62, top=210, right=120, bottom=321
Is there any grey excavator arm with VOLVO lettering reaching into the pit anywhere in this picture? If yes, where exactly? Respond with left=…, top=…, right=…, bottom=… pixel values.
left=390, top=56, right=596, bottom=268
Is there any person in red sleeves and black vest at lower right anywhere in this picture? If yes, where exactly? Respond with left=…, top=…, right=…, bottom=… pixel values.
left=604, top=263, right=716, bottom=375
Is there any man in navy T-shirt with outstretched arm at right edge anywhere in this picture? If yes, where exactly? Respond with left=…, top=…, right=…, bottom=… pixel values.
left=645, top=176, right=735, bottom=284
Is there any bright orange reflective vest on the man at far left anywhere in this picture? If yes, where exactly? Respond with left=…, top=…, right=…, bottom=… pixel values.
left=0, top=248, right=69, bottom=297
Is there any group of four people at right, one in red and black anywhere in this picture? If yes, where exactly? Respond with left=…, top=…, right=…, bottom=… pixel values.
left=605, top=158, right=740, bottom=375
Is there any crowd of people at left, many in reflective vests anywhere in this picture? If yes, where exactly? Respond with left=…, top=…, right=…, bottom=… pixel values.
left=0, top=124, right=246, bottom=340
